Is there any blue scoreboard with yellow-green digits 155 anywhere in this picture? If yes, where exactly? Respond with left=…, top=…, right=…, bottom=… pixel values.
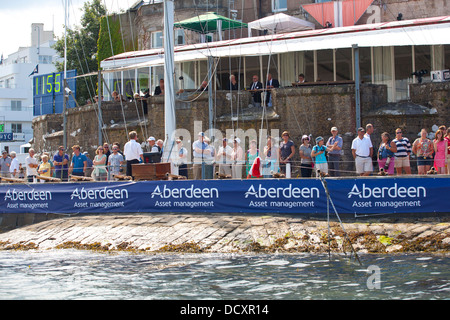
left=33, top=70, right=77, bottom=116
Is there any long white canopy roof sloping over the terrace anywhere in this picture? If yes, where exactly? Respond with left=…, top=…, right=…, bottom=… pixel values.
left=101, top=16, right=450, bottom=70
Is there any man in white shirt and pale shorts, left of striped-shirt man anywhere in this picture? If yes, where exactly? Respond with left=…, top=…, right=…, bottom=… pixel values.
left=352, top=128, right=373, bottom=176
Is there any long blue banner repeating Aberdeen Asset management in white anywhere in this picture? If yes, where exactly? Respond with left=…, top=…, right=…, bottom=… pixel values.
left=0, top=176, right=450, bottom=215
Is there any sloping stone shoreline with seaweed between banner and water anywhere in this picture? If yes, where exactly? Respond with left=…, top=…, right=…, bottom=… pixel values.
left=0, top=214, right=450, bottom=254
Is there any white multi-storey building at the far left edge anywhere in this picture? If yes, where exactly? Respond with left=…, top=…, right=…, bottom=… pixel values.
left=0, top=23, right=59, bottom=153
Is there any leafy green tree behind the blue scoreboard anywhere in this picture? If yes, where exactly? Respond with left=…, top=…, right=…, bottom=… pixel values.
left=54, top=0, right=106, bottom=105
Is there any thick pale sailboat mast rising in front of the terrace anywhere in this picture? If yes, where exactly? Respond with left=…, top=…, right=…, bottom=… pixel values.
left=164, top=0, right=176, bottom=142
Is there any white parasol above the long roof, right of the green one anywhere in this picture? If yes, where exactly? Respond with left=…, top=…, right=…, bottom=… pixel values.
left=248, top=13, right=315, bottom=37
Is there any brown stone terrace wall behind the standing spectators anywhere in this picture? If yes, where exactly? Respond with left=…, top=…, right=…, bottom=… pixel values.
left=33, top=83, right=450, bottom=172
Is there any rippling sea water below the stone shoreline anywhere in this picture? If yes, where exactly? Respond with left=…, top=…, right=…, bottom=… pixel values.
left=0, top=250, right=450, bottom=300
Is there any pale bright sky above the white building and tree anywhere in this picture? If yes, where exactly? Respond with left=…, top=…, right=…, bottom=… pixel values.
left=0, top=0, right=130, bottom=58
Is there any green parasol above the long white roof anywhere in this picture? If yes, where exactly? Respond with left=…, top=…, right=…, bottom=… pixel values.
left=174, top=12, right=247, bottom=34
